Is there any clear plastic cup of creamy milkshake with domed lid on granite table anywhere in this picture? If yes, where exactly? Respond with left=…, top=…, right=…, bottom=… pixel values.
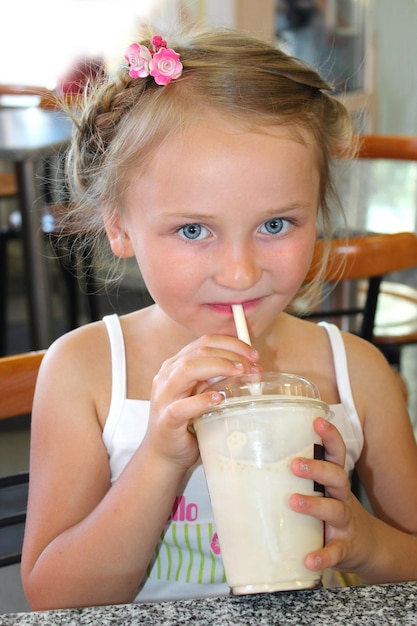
left=192, top=372, right=331, bottom=595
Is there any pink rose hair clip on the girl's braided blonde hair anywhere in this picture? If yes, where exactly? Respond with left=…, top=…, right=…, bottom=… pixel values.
left=125, top=35, right=183, bottom=85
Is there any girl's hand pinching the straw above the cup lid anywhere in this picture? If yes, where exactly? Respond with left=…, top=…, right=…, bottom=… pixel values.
left=143, top=335, right=259, bottom=469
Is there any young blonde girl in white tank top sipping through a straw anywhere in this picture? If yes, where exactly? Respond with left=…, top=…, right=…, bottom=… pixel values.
left=22, top=26, right=417, bottom=609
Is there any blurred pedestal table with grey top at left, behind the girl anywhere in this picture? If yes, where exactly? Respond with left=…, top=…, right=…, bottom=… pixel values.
left=0, top=107, right=72, bottom=349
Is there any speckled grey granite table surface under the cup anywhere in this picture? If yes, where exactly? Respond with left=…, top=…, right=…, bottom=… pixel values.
left=0, top=583, right=417, bottom=626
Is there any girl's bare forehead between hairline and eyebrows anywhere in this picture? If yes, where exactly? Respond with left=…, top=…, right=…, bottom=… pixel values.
left=128, top=118, right=319, bottom=210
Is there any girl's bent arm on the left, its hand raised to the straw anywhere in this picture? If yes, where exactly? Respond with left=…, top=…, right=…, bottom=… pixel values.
left=22, top=324, right=258, bottom=609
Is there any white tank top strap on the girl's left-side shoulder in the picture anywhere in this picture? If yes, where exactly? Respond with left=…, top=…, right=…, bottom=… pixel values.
left=103, top=314, right=126, bottom=437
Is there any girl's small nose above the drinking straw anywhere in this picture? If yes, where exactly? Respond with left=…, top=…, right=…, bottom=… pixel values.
left=214, top=245, right=262, bottom=291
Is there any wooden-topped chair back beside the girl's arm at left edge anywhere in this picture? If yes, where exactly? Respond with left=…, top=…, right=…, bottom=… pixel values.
left=0, top=351, right=45, bottom=567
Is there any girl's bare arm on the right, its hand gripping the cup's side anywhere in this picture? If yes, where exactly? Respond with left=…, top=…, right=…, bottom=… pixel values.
left=291, top=337, right=417, bottom=583
